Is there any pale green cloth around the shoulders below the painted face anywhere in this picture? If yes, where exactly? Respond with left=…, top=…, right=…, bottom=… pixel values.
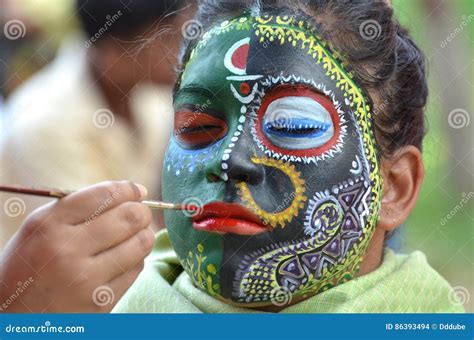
left=113, top=230, right=464, bottom=313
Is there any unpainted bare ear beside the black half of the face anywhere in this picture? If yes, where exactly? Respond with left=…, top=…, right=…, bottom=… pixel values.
left=377, top=145, right=425, bottom=232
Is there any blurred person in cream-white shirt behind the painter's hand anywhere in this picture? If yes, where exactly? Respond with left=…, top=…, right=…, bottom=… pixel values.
left=0, top=0, right=192, bottom=249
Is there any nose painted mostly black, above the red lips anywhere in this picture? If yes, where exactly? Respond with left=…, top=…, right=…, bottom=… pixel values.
left=222, top=130, right=265, bottom=185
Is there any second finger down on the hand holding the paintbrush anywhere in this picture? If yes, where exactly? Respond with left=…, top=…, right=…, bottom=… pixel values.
left=81, top=202, right=153, bottom=254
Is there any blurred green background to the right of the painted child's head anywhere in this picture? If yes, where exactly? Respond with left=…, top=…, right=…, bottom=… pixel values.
left=392, top=0, right=474, bottom=312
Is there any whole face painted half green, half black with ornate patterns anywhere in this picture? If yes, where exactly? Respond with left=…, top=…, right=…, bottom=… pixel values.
left=163, top=16, right=381, bottom=306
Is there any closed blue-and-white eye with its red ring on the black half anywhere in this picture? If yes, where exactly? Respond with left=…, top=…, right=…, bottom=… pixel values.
left=257, top=86, right=340, bottom=156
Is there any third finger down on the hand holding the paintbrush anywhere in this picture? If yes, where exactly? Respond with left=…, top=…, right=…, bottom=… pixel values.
left=95, top=228, right=155, bottom=281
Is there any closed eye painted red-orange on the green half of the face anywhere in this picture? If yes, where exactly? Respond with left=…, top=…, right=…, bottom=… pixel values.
left=174, top=109, right=228, bottom=149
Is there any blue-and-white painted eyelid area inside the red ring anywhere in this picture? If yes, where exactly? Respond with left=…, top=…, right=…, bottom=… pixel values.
left=262, top=96, right=334, bottom=150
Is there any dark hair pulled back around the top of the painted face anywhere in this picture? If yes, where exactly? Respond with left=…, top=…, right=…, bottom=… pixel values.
left=176, top=0, right=428, bottom=156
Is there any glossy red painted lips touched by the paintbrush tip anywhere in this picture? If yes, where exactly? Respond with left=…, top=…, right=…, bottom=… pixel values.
left=192, top=202, right=270, bottom=235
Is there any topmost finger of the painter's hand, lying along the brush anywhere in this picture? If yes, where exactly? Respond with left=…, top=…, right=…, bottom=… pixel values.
left=54, top=181, right=146, bottom=224
